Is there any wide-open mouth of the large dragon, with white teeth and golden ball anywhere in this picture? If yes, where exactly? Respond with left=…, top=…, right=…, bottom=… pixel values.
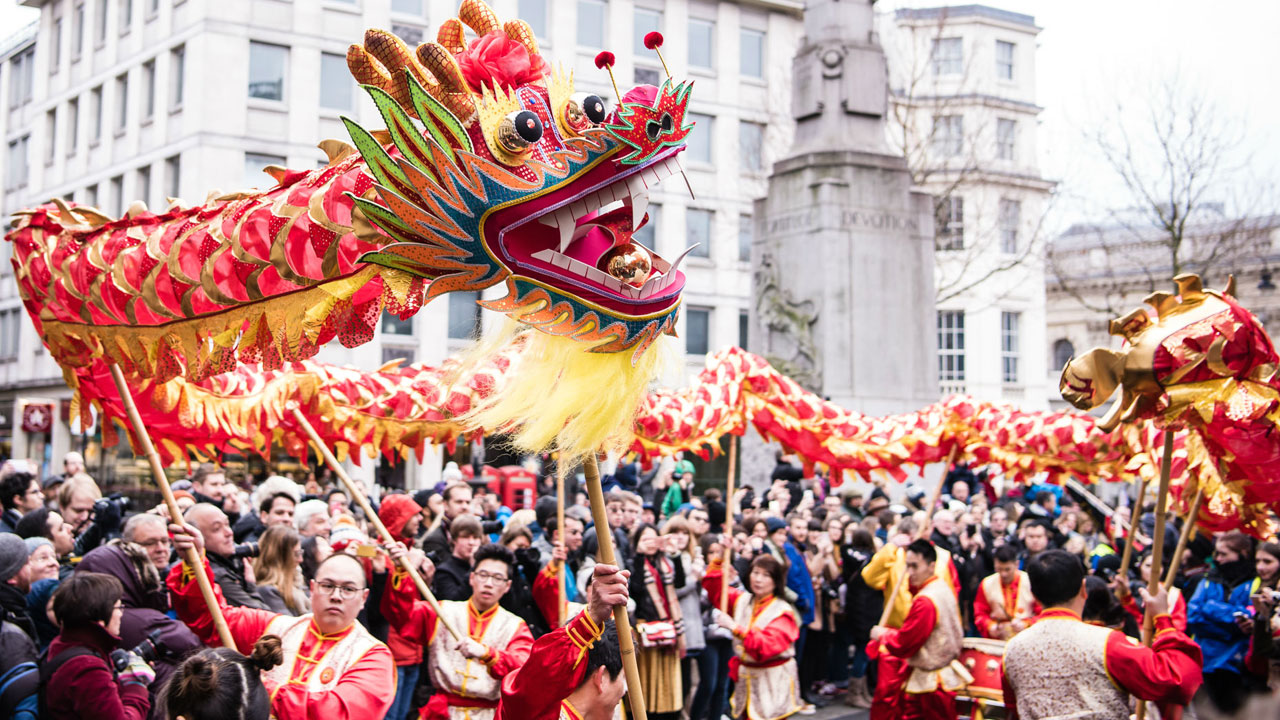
left=486, top=147, right=689, bottom=305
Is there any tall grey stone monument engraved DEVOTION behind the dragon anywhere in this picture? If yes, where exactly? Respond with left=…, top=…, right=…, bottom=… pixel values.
left=742, top=0, right=938, bottom=479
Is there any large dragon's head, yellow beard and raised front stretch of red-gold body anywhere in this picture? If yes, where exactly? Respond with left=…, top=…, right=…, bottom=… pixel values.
left=8, top=0, right=691, bottom=455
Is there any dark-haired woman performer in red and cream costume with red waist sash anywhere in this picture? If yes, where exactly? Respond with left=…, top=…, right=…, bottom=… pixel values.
left=703, top=553, right=805, bottom=720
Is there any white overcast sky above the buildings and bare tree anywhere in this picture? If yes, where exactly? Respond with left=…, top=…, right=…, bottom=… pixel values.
left=0, top=0, right=1280, bottom=227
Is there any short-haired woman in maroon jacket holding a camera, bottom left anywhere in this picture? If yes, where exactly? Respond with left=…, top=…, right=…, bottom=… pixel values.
left=41, top=571, right=156, bottom=720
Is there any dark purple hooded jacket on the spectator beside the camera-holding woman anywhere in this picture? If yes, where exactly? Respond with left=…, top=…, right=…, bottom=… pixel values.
left=77, top=541, right=204, bottom=717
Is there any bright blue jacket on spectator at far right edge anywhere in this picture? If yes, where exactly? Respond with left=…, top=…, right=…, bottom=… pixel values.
left=1187, top=570, right=1258, bottom=673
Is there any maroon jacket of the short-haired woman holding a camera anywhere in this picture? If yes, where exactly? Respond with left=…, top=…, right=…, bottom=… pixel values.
left=47, top=625, right=151, bottom=720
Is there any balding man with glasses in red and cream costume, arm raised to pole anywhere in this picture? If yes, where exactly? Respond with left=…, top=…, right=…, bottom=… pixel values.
left=168, top=524, right=396, bottom=720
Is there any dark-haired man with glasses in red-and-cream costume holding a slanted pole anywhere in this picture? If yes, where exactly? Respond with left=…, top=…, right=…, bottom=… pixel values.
left=383, top=542, right=534, bottom=720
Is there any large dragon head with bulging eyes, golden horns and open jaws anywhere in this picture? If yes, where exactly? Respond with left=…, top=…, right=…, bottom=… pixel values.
left=346, top=0, right=691, bottom=354
